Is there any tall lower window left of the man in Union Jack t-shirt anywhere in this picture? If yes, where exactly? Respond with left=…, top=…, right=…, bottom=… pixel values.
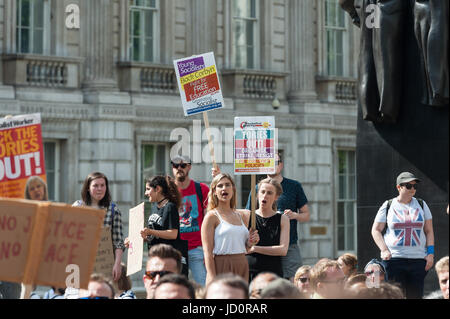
left=336, top=150, right=356, bottom=254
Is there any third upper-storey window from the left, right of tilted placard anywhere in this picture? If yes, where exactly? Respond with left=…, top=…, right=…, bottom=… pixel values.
left=232, top=0, right=259, bottom=69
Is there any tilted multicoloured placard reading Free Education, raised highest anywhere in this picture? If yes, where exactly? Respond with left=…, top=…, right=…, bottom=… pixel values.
left=173, top=52, right=224, bottom=116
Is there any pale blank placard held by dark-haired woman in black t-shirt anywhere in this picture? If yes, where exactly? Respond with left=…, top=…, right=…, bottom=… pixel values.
left=127, top=203, right=144, bottom=276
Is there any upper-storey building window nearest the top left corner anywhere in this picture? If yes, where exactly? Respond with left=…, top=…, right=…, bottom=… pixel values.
left=16, top=0, right=50, bottom=54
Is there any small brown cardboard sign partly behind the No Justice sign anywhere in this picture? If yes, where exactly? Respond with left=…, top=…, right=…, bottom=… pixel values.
left=93, top=227, right=114, bottom=278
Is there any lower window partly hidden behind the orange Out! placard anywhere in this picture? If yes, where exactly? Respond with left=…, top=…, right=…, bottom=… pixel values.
left=44, top=141, right=60, bottom=202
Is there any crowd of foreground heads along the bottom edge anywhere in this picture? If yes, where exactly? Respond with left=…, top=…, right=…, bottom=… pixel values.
left=95, top=244, right=442, bottom=299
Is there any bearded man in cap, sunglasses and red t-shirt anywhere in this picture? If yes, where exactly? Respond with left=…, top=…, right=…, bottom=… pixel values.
left=171, top=156, right=209, bottom=286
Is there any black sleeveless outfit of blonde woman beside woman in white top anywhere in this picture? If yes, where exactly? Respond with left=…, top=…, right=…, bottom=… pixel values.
left=247, top=213, right=283, bottom=279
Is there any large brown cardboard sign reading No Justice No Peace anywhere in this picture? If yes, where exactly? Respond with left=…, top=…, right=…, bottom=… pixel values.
left=0, top=198, right=105, bottom=288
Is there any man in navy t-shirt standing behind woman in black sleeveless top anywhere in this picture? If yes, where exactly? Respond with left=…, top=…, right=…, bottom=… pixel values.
left=246, top=153, right=310, bottom=282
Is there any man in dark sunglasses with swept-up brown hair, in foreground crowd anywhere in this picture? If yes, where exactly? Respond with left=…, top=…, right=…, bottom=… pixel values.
left=142, top=244, right=182, bottom=299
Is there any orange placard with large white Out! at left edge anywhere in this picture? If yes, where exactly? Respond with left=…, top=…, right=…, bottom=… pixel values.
left=0, top=113, right=46, bottom=198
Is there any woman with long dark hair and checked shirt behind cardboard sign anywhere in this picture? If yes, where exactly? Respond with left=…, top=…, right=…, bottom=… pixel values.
left=72, top=172, right=125, bottom=281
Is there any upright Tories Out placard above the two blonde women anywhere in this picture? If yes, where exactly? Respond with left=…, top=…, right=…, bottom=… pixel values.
left=234, top=116, right=277, bottom=175
